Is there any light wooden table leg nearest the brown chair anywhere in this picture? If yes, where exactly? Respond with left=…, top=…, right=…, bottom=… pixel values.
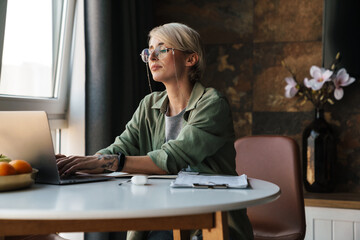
left=202, top=212, right=229, bottom=240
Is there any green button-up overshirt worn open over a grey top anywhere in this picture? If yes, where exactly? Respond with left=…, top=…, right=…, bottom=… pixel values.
left=98, top=83, right=252, bottom=239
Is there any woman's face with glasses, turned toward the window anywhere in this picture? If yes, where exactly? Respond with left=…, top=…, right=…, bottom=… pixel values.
left=149, top=37, right=187, bottom=83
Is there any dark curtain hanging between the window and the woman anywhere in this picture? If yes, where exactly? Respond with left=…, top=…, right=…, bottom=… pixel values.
left=84, top=0, right=153, bottom=240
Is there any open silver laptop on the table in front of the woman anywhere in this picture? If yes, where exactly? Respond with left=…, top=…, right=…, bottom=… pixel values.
left=0, top=111, right=110, bottom=184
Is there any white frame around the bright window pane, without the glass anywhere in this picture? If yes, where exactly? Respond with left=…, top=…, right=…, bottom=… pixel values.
left=0, top=0, right=76, bottom=120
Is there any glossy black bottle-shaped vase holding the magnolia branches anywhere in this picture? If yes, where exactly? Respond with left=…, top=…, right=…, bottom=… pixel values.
left=302, top=108, right=336, bottom=193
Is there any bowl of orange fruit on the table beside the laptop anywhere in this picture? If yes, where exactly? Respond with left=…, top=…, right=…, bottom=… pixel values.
left=0, top=154, right=38, bottom=191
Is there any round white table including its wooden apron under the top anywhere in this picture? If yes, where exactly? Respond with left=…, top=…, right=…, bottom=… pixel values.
left=0, top=178, right=280, bottom=239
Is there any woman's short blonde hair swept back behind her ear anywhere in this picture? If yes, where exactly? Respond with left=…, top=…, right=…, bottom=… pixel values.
left=149, top=23, right=205, bottom=82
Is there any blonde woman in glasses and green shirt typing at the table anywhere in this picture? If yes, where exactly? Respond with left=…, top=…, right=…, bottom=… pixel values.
left=58, top=23, right=253, bottom=239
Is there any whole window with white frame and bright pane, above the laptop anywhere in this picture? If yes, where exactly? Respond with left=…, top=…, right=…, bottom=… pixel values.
left=0, top=0, right=76, bottom=119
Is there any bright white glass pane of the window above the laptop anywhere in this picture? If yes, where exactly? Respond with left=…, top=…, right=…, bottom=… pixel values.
left=0, top=0, right=55, bottom=97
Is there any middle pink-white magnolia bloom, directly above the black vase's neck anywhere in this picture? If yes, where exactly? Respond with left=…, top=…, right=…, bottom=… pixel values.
left=304, top=66, right=333, bottom=91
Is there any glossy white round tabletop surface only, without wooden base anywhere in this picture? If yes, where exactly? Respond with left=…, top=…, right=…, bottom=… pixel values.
left=0, top=179, right=280, bottom=219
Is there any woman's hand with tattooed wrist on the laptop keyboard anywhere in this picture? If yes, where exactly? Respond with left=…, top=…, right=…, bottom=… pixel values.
left=56, top=154, right=118, bottom=176
